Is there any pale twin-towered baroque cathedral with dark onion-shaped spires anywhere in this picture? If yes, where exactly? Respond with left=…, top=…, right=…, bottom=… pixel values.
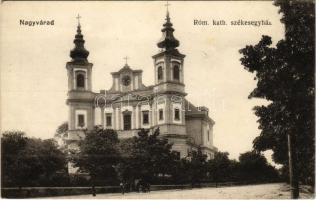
left=66, top=11, right=217, bottom=172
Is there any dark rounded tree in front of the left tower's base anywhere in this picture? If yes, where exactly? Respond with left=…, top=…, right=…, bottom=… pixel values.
left=71, top=127, right=120, bottom=184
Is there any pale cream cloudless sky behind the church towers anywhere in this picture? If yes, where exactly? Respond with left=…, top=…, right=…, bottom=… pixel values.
left=0, top=1, right=284, bottom=162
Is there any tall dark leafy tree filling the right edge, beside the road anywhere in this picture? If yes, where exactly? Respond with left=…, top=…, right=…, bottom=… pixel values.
left=240, top=0, right=315, bottom=196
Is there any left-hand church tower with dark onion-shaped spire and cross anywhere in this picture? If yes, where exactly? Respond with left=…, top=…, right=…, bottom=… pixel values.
left=66, top=16, right=94, bottom=164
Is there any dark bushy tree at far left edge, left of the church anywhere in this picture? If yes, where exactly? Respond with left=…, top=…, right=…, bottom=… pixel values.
left=1, top=131, right=66, bottom=187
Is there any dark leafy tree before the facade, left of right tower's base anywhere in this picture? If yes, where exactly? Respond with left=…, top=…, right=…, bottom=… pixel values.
left=118, top=129, right=175, bottom=184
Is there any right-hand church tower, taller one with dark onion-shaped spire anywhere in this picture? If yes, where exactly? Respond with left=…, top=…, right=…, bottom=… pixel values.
left=152, top=9, right=187, bottom=152
